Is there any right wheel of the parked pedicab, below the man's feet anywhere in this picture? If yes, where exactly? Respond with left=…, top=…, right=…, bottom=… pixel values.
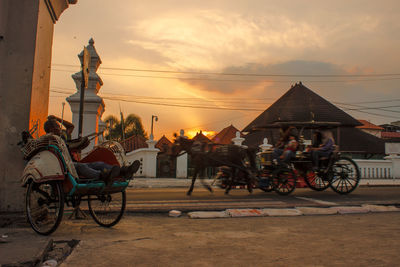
left=88, top=191, right=126, bottom=227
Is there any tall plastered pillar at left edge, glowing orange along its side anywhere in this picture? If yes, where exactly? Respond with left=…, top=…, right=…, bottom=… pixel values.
left=0, top=0, right=77, bottom=214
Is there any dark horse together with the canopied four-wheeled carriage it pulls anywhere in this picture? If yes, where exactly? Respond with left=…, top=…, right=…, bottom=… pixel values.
left=175, top=122, right=360, bottom=195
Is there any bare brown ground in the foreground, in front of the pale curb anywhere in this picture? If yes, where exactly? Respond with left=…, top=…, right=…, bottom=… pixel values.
left=50, top=212, right=400, bottom=267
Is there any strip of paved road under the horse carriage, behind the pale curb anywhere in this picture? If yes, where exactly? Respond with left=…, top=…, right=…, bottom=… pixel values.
left=122, top=186, right=400, bottom=212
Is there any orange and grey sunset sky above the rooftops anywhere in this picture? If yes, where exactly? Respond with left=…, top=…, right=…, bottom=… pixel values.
left=49, top=0, right=400, bottom=139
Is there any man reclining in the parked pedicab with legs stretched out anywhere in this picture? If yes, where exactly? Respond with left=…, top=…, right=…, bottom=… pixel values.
left=44, top=115, right=140, bottom=185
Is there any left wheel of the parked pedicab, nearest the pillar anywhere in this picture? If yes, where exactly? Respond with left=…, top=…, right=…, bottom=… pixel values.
left=25, top=181, right=64, bottom=235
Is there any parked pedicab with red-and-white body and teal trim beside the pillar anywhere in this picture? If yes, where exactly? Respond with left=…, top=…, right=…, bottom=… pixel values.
left=20, top=132, right=130, bottom=235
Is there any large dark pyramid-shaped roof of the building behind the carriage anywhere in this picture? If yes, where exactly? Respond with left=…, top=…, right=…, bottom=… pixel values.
left=242, top=82, right=385, bottom=154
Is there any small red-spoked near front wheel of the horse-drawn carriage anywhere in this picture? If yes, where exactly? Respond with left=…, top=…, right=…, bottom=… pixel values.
left=272, top=168, right=297, bottom=195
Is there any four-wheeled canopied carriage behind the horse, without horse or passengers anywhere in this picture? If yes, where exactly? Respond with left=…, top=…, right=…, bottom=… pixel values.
left=259, top=122, right=361, bottom=195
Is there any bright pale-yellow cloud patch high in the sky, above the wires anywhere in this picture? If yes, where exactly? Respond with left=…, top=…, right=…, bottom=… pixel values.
left=129, top=9, right=325, bottom=70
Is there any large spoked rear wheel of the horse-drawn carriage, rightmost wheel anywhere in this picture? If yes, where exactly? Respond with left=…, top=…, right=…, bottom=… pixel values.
left=330, top=157, right=360, bottom=194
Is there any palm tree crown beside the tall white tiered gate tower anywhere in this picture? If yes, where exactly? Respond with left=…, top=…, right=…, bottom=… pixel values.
left=104, top=114, right=147, bottom=141
